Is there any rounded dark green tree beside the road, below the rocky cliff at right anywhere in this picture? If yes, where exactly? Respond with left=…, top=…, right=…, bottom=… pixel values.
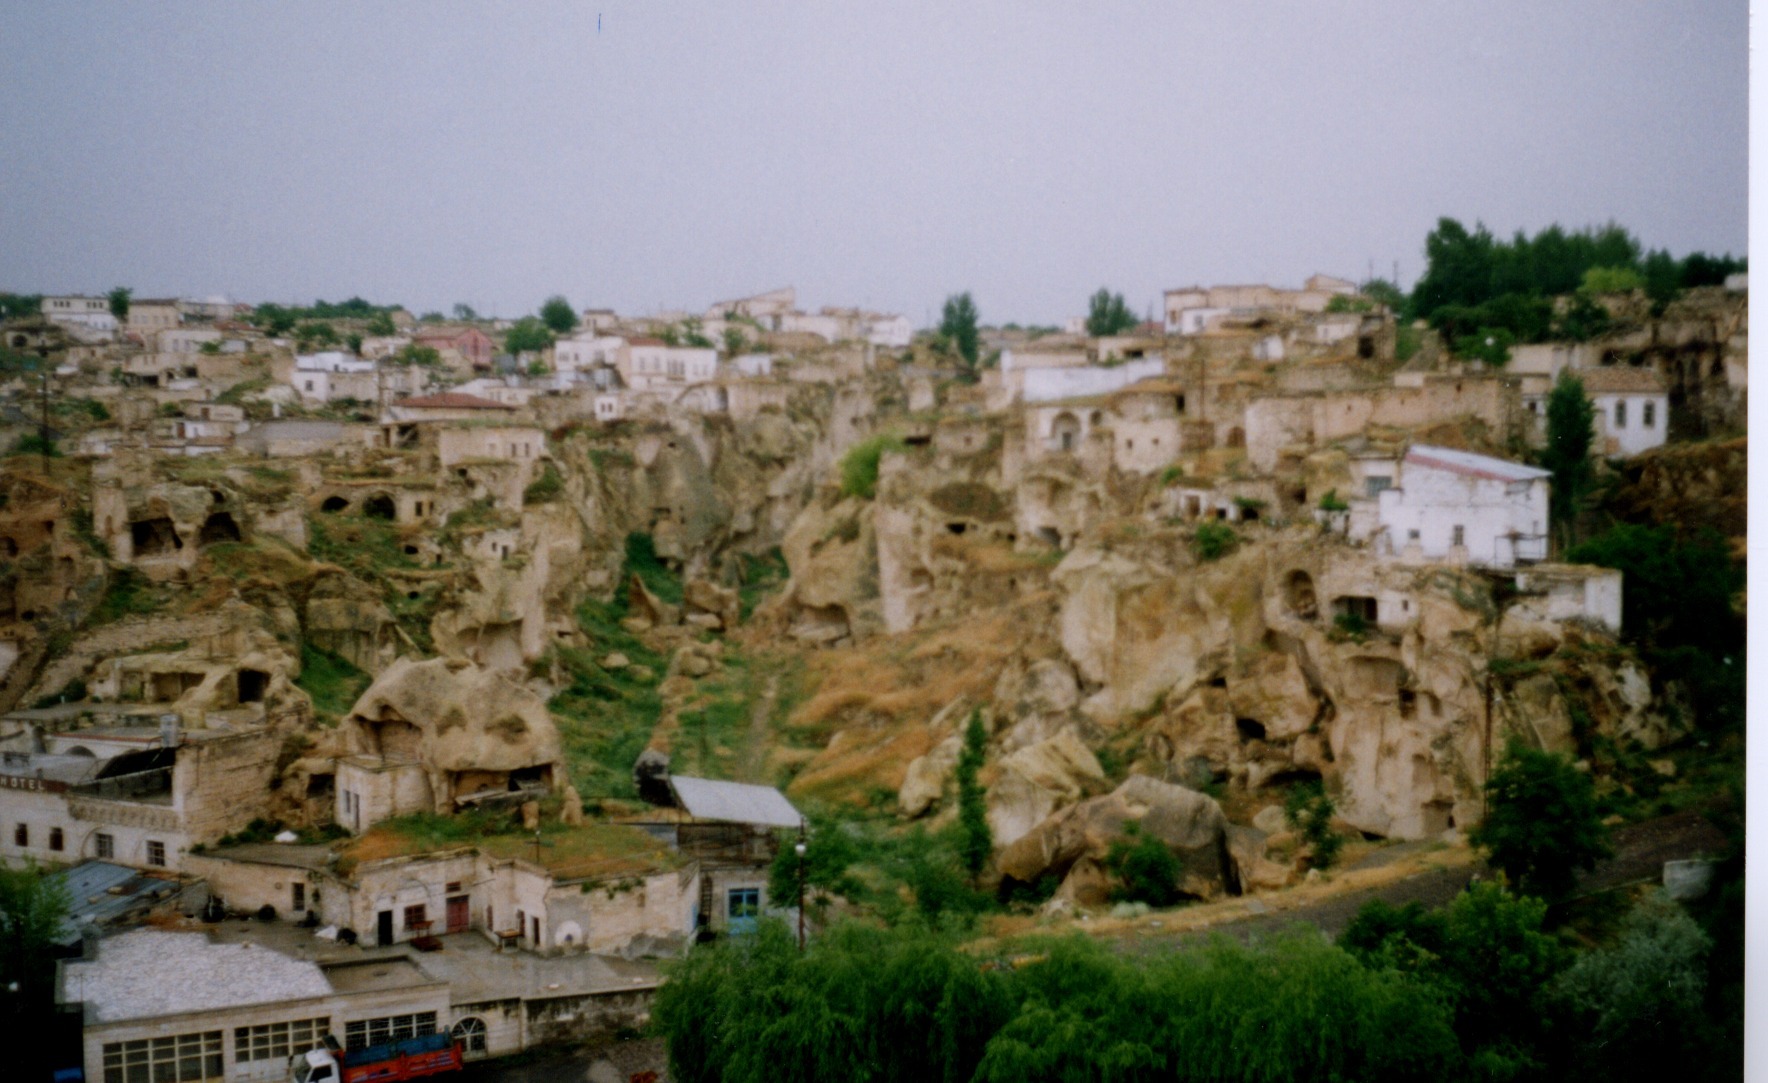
left=1469, top=740, right=1611, bottom=901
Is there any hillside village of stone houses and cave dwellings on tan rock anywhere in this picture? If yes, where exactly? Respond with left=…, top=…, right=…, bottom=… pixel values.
left=0, top=274, right=1749, bottom=1083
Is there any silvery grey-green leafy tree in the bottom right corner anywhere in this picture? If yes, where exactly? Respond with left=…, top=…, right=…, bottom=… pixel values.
left=1552, top=894, right=1713, bottom=1079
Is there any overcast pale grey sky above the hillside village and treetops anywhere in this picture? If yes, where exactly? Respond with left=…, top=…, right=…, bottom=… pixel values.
left=0, top=0, right=1749, bottom=323
